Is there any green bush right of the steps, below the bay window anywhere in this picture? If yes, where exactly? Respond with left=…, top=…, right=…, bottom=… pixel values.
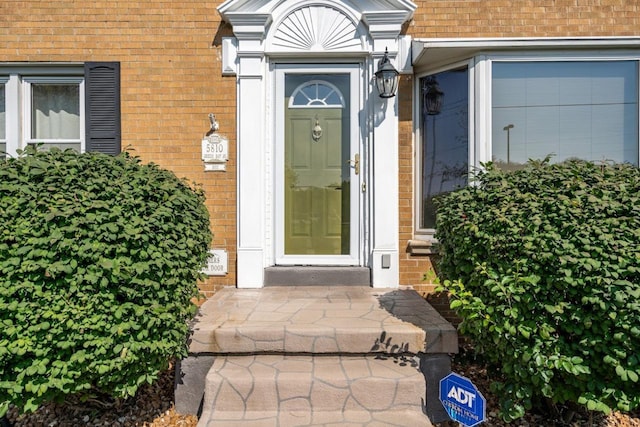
left=437, top=160, right=640, bottom=420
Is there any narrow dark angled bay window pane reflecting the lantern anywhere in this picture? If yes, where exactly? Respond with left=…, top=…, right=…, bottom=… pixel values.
left=418, top=67, right=469, bottom=229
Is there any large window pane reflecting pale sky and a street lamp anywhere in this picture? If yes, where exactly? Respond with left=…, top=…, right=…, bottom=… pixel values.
left=491, top=61, right=638, bottom=169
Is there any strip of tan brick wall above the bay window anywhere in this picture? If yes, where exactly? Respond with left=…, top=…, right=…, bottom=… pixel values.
left=408, top=0, right=640, bottom=38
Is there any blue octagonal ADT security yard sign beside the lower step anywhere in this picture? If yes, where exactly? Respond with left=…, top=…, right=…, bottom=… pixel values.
left=440, top=373, right=486, bottom=427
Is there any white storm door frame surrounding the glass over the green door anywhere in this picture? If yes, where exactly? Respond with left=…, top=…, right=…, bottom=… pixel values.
left=273, top=63, right=366, bottom=266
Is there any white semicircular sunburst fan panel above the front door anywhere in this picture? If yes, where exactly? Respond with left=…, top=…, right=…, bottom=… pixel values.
left=273, top=6, right=361, bottom=51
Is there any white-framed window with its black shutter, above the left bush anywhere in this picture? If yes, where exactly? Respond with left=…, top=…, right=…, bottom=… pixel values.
left=0, top=63, right=120, bottom=155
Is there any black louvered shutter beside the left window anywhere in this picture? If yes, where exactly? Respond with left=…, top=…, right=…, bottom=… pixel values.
left=84, top=62, right=122, bottom=155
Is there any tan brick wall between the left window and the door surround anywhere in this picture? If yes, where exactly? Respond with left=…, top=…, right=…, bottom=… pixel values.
left=0, top=0, right=236, bottom=293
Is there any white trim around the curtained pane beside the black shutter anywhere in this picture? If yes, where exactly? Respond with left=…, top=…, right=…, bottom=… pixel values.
left=21, top=76, right=86, bottom=153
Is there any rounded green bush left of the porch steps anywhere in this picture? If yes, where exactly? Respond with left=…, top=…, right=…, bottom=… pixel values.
left=0, top=148, right=211, bottom=416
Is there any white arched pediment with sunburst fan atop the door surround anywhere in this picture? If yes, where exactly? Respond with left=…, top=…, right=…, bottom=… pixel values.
left=218, top=0, right=416, bottom=53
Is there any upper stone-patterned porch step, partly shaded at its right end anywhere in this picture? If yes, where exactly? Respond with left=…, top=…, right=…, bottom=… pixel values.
left=189, top=286, right=457, bottom=354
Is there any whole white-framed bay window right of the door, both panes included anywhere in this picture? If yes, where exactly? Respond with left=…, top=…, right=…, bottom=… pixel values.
left=416, top=50, right=640, bottom=239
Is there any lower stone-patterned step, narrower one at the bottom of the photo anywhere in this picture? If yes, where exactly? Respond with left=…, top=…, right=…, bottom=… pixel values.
left=198, top=354, right=431, bottom=427
